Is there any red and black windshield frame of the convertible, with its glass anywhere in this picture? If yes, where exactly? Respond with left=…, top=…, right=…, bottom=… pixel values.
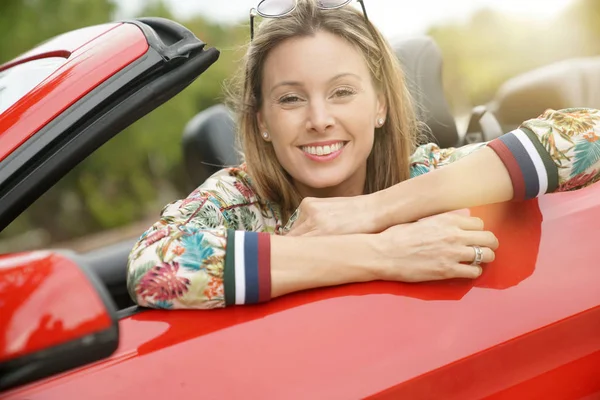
left=0, top=18, right=219, bottom=230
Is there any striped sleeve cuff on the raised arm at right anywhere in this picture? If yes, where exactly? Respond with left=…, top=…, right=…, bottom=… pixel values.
left=488, top=127, right=558, bottom=200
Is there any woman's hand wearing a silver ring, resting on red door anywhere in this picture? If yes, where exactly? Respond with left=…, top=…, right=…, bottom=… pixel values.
left=373, top=213, right=498, bottom=282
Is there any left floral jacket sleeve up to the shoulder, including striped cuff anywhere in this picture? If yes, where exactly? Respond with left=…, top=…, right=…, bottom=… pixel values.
left=127, top=168, right=270, bottom=309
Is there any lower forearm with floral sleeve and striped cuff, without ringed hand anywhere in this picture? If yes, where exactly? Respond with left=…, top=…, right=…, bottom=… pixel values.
left=128, top=217, right=375, bottom=309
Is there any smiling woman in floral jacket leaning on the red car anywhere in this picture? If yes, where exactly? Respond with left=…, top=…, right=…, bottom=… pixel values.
left=128, top=0, right=600, bottom=308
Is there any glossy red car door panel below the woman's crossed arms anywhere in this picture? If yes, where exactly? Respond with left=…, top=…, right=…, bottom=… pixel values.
left=6, top=184, right=600, bottom=400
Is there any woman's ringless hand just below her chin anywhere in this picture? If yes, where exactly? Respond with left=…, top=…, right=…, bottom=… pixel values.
left=284, top=195, right=377, bottom=236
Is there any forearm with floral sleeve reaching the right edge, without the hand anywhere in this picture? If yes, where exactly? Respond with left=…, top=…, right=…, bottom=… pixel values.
left=375, top=109, right=600, bottom=226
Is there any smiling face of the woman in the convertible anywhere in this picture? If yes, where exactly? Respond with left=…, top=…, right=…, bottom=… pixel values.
left=258, top=32, right=386, bottom=197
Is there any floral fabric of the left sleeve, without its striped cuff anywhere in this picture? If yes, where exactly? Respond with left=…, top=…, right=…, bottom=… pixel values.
left=127, top=194, right=232, bottom=309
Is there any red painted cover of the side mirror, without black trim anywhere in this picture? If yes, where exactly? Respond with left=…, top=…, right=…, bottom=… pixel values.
left=0, top=252, right=111, bottom=362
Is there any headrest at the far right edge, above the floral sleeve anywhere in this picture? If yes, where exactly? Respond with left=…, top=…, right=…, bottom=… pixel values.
left=488, top=57, right=600, bottom=131
